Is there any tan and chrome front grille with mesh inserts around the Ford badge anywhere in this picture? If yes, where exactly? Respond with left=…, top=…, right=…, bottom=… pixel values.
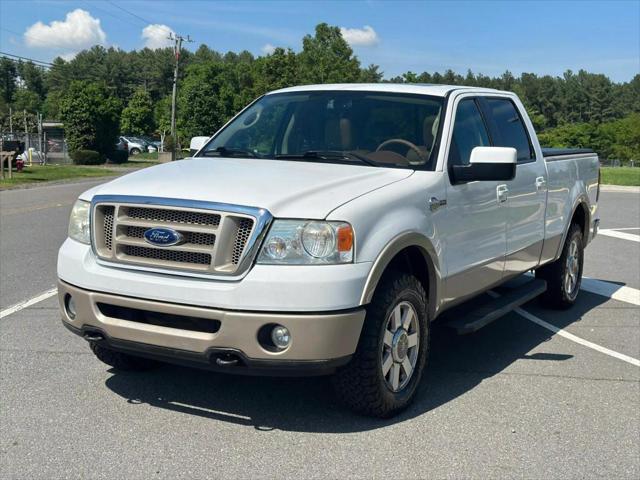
left=92, top=196, right=271, bottom=276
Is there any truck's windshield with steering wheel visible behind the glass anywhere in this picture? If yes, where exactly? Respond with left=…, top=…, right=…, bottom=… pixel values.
left=199, top=91, right=443, bottom=169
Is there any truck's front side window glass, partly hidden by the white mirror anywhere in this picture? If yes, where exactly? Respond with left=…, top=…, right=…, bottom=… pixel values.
left=449, top=98, right=489, bottom=166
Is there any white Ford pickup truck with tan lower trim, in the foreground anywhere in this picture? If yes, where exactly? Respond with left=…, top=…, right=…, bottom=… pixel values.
left=58, top=84, right=599, bottom=417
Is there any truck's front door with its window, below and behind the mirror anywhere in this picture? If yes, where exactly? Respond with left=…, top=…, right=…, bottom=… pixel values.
left=433, top=96, right=507, bottom=302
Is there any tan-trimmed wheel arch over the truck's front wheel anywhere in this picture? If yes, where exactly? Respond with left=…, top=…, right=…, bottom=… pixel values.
left=360, top=232, right=442, bottom=319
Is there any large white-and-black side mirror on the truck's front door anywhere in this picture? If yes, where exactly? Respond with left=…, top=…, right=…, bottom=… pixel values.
left=452, top=147, right=518, bottom=183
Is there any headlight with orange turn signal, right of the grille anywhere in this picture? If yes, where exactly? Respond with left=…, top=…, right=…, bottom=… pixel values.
left=258, top=220, right=354, bottom=265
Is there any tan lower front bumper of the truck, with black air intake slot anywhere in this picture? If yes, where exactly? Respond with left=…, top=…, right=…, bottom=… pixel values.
left=58, top=281, right=365, bottom=375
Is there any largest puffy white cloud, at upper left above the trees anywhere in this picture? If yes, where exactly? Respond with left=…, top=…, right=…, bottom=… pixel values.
left=24, top=8, right=107, bottom=52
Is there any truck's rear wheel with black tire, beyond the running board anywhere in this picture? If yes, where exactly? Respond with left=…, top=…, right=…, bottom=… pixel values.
left=536, top=224, right=584, bottom=309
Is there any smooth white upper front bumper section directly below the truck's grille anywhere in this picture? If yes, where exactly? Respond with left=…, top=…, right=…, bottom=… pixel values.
left=58, top=238, right=373, bottom=313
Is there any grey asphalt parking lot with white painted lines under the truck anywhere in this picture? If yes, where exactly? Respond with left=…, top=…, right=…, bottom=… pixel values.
left=0, top=182, right=640, bottom=479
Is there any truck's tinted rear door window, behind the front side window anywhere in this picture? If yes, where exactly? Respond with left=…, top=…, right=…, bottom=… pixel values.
left=487, top=98, right=534, bottom=162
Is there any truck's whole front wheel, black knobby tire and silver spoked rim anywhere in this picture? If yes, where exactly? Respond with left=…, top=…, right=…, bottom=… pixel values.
left=333, top=274, right=429, bottom=418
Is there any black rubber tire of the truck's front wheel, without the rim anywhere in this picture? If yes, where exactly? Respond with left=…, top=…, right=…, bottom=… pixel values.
left=333, top=273, right=429, bottom=418
